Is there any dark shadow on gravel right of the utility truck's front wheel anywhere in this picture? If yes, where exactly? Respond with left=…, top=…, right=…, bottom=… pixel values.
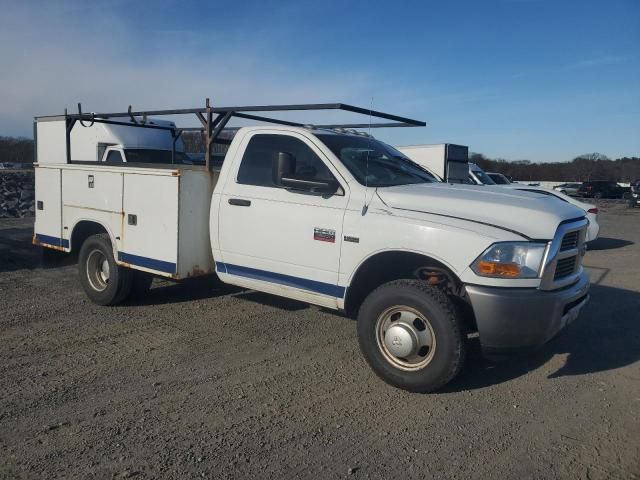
left=441, top=285, right=640, bottom=393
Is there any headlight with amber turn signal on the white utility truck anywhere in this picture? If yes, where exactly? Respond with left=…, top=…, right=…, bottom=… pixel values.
left=471, top=242, right=547, bottom=278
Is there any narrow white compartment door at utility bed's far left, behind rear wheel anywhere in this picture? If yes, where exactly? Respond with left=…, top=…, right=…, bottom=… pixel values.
left=34, top=167, right=63, bottom=247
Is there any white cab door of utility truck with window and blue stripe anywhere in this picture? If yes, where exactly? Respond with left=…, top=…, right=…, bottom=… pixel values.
left=216, top=130, right=348, bottom=303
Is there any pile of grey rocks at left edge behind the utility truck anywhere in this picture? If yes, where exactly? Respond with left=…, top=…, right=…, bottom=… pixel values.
left=0, top=171, right=35, bottom=218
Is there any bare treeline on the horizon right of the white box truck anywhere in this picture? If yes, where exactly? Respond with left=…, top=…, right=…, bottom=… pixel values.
left=469, top=153, right=640, bottom=182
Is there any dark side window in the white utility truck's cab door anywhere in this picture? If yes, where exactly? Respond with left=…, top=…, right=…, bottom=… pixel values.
left=237, top=134, right=334, bottom=188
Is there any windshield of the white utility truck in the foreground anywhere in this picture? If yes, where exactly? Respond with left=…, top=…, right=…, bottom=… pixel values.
left=317, top=134, right=438, bottom=187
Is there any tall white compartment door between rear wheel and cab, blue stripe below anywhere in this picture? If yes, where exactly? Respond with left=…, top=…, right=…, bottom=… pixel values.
left=118, top=173, right=179, bottom=276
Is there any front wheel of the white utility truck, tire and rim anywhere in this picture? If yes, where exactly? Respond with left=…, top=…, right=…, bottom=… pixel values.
left=358, top=280, right=465, bottom=393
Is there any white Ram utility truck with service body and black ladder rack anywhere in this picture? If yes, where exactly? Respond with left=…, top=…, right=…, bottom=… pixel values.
left=34, top=103, right=589, bottom=392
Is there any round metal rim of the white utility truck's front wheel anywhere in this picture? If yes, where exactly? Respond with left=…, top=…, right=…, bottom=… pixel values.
left=376, top=306, right=436, bottom=371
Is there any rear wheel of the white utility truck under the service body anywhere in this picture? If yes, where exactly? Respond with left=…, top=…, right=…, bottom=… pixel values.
left=78, top=234, right=133, bottom=305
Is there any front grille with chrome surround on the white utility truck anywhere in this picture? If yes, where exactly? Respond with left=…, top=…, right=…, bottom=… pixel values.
left=540, top=219, right=589, bottom=290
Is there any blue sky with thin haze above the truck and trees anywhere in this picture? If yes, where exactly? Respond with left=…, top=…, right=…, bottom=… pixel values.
left=0, top=0, right=640, bottom=161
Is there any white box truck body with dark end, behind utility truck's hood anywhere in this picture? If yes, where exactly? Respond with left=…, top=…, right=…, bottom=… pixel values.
left=396, top=143, right=469, bottom=183
